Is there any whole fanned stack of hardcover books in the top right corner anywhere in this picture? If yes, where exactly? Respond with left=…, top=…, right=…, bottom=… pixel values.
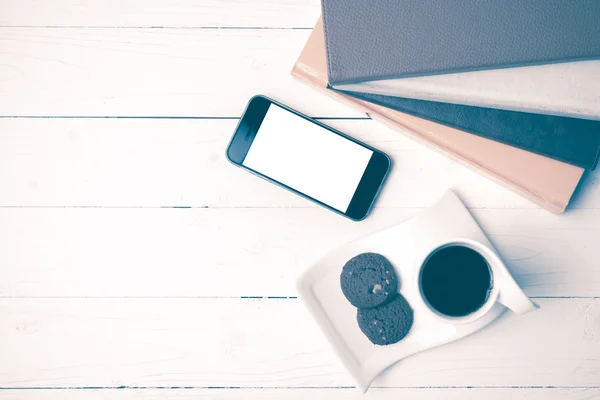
left=292, top=0, right=600, bottom=213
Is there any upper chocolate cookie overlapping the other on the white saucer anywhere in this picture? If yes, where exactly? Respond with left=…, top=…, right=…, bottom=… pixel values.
left=340, top=253, right=398, bottom=308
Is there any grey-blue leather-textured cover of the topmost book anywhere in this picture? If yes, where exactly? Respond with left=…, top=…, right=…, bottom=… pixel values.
left=322, top=0, right=600, bottom=83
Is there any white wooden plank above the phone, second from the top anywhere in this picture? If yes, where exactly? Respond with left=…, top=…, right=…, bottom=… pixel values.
left=0, top=28, right=356, bottom=117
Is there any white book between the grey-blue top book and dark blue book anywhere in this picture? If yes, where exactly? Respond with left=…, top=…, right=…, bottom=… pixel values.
left=334, top=60, right=600, bottom=120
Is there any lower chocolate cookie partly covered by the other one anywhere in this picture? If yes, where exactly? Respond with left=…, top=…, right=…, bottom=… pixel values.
left=356, top=294, right=413, bottom=346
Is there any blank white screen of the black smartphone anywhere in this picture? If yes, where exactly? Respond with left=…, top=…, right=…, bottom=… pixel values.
left=242, top=104, right=373, bottom=213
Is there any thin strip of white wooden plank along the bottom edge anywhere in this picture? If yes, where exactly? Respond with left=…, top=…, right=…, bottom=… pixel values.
left=0, top=388, right=600, bottom=400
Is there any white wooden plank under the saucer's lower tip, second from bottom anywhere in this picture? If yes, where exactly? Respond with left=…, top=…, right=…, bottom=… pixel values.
left=0, top=299, right=600, bottom=388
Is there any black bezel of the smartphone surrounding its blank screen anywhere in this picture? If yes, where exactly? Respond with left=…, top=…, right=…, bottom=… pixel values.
left=227, top=95, right=392, bottom=221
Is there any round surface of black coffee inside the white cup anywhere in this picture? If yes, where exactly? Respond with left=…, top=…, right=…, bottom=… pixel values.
left=421, top=245, right=492, bottom=317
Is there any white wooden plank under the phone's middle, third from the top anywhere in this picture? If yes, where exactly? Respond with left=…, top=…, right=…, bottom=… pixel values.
left=0, top=119, right=584, bottom=208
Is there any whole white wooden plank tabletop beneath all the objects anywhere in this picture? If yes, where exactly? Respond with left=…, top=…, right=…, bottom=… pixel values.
left=0, top=0, right=600, bottom=400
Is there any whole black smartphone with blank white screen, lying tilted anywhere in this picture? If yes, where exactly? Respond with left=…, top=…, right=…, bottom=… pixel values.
left=227, top=96, right=391, bottom=221
